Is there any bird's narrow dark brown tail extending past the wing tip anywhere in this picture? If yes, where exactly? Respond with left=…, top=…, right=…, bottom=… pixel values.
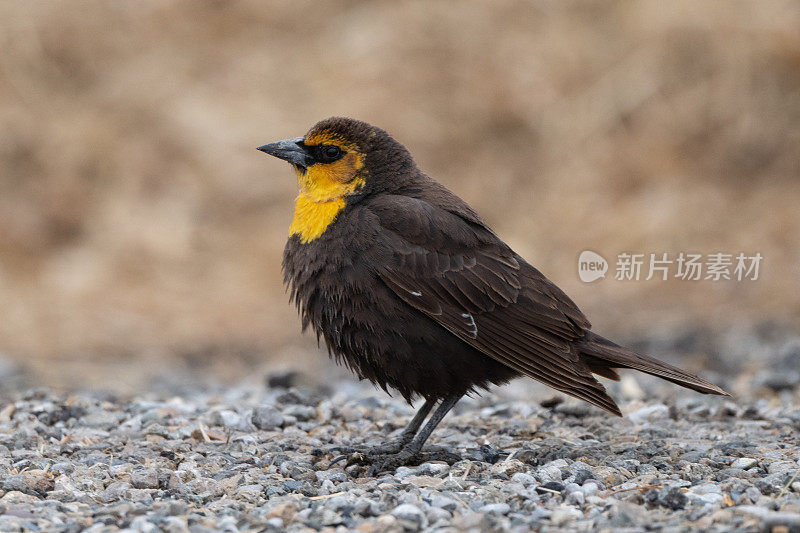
left=578, top=331, right=730, bottom=396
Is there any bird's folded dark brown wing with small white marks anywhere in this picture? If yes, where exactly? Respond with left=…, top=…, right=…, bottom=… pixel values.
left=370, top=196, right=620, bottom=415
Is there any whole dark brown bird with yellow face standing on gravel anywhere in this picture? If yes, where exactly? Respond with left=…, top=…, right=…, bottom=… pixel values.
left=258, top=117, right=728, bottom=474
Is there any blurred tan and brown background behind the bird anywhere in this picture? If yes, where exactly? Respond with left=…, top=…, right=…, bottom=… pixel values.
left=0, top=0, right=800, bottom=392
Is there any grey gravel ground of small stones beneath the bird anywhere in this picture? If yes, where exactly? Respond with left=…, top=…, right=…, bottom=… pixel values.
left=0, top=366, right=800, bottom=532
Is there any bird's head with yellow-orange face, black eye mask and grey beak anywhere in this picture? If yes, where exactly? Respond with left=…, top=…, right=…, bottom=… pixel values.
left=258, top=117, right=413, bottom=202
